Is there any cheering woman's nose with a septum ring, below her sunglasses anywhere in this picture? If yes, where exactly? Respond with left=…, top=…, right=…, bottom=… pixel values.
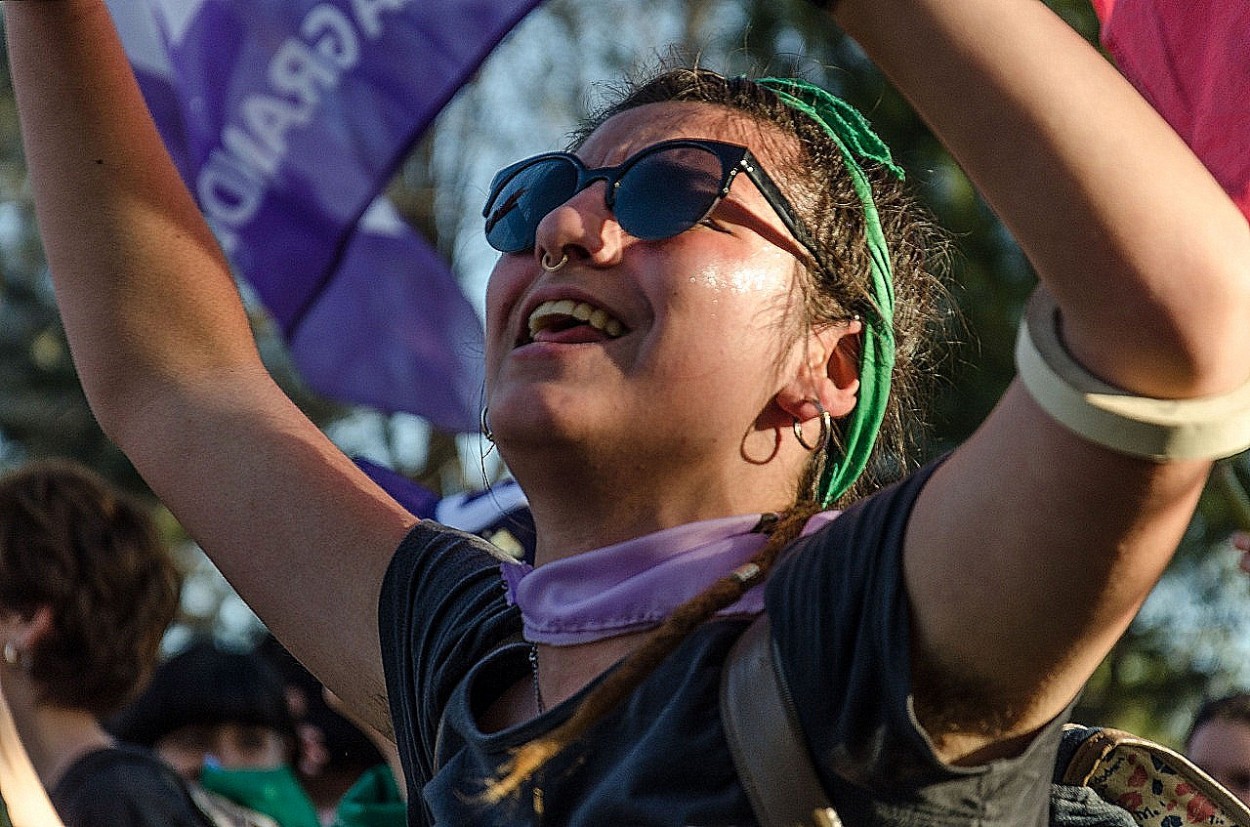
left=534, top=181, right=625, bottom=267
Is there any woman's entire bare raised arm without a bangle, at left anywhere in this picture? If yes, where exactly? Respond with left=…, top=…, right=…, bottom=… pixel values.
left=4, top=0, right=415, bottom=731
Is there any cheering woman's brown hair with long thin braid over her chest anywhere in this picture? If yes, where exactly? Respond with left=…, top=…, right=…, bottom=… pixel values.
left=485, top=69, right=949, bottom=801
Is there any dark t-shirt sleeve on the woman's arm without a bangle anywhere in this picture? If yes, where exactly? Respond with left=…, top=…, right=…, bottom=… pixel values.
left=378, top=521, right=520, bottom=793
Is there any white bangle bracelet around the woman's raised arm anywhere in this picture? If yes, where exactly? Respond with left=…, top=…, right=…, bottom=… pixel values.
left=1016, top=289, right=1250, bottom=461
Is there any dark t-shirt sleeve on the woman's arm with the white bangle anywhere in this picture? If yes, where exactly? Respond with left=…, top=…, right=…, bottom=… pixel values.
left=766, top=465, right=943, bottom=788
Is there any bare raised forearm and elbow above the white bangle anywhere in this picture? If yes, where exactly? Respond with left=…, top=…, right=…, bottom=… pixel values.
left=839, top=0, right=1250, bottom=397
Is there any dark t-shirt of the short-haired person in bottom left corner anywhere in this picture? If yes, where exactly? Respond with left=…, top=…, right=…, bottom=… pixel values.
left=49, top=745, right=213, bottom=827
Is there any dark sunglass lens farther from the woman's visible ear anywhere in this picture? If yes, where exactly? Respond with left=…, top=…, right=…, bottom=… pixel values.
left=486, top=157, right=578, bottom=252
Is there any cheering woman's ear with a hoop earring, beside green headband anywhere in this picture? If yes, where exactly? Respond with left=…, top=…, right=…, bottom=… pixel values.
left=776, top=319, right=864, bottom=422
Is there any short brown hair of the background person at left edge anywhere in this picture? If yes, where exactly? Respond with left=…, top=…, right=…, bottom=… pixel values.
left=0, top=461, right=180, bottom=715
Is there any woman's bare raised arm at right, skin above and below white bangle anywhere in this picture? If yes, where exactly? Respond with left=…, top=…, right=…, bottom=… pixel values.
left=838, top=0, right=1250, bottom=761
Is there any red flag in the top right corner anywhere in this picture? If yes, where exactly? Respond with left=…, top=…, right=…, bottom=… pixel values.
left=1094, top=0, right=1250, bottom=223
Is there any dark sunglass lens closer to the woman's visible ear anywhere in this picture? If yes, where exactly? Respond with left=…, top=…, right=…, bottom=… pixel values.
left=613, top=146, right=724, bottom=241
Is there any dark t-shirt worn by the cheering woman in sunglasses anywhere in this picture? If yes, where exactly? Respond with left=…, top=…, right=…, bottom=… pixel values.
left=379, top=470, right=1061, bottom=827
